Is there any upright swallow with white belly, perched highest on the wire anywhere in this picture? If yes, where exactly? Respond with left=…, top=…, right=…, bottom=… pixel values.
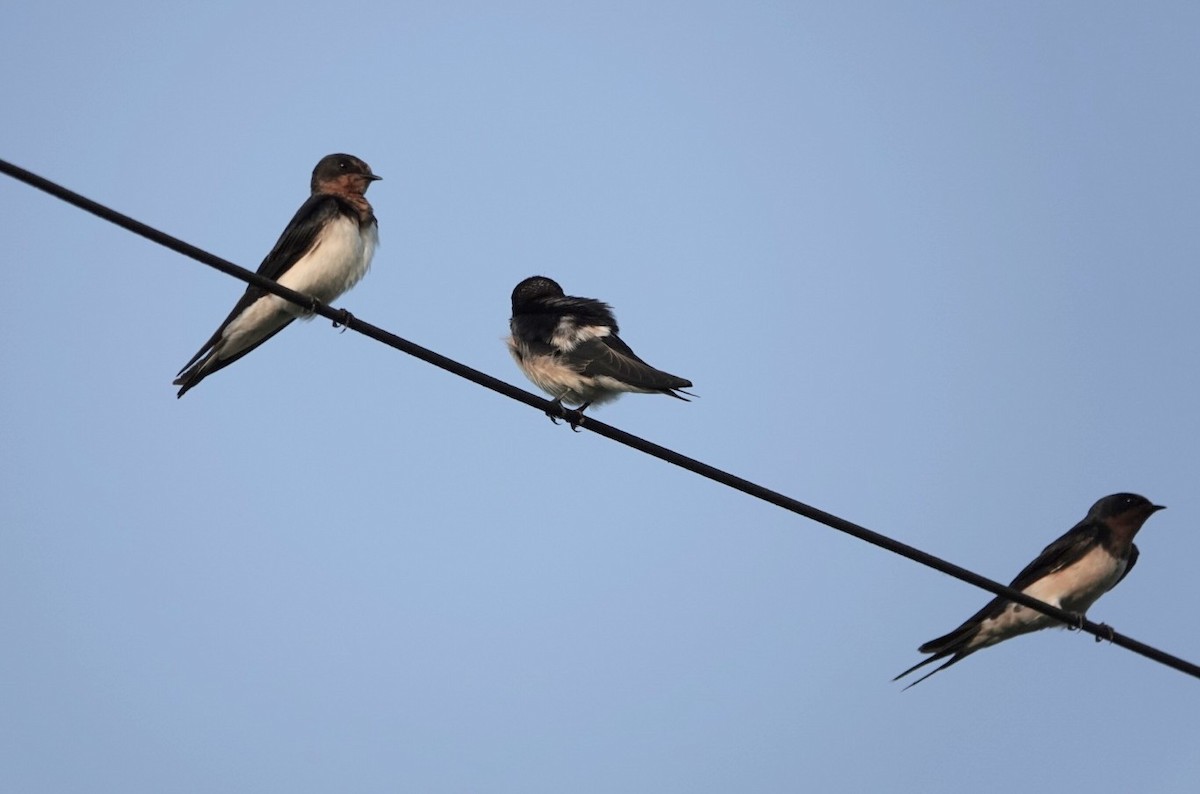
left=175, top=155, right=380, bottom=397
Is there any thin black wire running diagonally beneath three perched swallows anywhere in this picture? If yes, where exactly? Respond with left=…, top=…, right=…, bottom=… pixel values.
left=0, top=160, right=1200, bottom=678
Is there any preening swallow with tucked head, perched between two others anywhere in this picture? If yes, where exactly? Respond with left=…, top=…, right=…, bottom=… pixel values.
left=506, top=276, right=694, bottom=428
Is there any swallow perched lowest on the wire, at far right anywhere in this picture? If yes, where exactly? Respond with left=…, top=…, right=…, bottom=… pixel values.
left=892, top=493, right=1164, bottom=690
